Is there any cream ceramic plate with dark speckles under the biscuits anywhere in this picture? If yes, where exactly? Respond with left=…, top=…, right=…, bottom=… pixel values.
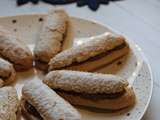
left=0, top=14, right=153, bottom=120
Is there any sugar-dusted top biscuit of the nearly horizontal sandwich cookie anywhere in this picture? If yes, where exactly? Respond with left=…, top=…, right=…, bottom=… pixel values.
left=43, top=70, right=128, bottom=94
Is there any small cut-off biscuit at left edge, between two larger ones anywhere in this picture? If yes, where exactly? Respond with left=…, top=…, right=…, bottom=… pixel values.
left=0, top=58, right=16, bottom=86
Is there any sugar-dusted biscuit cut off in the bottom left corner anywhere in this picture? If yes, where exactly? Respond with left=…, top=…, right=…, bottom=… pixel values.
left=0, top=87, right=20, bottom=120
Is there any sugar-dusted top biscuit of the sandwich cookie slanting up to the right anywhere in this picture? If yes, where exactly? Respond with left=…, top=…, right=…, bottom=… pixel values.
left=49, top=33, right=127, bottom=70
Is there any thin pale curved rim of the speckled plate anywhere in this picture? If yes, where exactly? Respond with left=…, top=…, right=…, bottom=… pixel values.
left=0, top=13, right=154, bottom=120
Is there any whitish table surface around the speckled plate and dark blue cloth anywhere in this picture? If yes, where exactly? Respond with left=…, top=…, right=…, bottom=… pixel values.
left=0, top=0, right=160, bottom=120
